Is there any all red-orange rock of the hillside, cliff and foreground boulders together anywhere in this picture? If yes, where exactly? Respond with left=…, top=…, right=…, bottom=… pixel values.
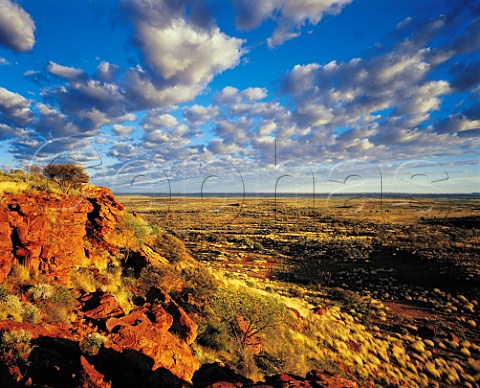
left=0, top=186, right=356, bottom=387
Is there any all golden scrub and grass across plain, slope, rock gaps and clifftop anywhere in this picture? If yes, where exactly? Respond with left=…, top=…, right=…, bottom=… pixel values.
left=0, top=168, right=480, bottom=387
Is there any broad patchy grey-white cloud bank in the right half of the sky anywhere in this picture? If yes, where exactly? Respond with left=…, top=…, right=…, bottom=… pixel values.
left=281, top=43, right=451, bottom=135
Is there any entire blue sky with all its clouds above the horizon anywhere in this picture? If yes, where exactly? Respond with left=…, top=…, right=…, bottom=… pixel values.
left=0, top=0, right=480, bottom=193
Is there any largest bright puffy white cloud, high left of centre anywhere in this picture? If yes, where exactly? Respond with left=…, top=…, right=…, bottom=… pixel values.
left=124, top=0, right=244, bottom=105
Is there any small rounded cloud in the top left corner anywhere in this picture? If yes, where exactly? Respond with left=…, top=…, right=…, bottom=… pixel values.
left=0, top=0, right=35, bottom=52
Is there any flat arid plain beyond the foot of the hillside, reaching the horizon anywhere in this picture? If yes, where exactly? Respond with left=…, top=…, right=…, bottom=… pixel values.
left=121, top=196, right=480, bottom=386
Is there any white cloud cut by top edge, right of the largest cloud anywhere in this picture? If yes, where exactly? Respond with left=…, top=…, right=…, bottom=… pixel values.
left=234, top=0, right=351, bottom=47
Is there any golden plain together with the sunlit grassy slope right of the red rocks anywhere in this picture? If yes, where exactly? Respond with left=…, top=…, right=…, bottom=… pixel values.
left=128, top=197, right=480, bottom=386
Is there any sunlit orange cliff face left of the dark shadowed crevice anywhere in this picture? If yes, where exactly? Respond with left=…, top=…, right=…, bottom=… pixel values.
left=0, top=194, right=93, bottom=282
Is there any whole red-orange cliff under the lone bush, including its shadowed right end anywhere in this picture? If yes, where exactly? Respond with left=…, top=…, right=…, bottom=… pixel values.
left=0, top=186, right=123, bottom=284
